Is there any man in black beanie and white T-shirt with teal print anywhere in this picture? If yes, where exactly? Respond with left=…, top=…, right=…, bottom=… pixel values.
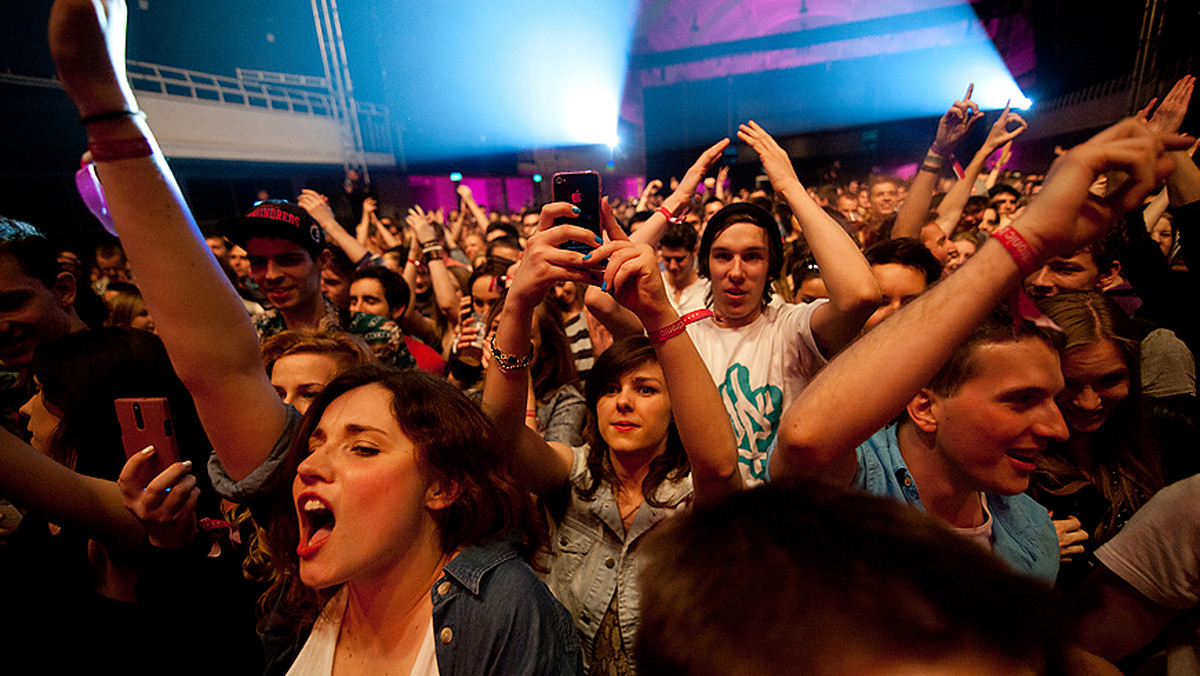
left=688, top=122, right=880, bottom=484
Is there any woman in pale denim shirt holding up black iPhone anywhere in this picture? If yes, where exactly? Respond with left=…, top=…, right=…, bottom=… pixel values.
left=484, top=198, right=742, bottom=674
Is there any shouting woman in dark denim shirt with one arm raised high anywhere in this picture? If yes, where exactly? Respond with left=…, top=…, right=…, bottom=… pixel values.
left=49, top=6, right=580, bottom=675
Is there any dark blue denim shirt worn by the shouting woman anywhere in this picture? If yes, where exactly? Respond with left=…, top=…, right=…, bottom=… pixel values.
left=209, top=406, right=583, bottom=676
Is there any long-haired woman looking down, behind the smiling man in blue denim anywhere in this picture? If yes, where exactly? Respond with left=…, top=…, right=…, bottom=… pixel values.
left=1030, top=293, right=1163, bottom=591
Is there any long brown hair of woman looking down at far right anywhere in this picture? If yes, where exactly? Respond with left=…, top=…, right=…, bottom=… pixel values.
left=1033, top=292, right=1163, bottom=545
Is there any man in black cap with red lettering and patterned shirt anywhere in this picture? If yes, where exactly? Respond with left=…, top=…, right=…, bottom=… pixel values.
left=221, top=199, right=415, bottom=367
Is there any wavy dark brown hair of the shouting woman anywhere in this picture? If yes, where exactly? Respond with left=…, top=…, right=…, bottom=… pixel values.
left=266, top=366, right=540, bottom=626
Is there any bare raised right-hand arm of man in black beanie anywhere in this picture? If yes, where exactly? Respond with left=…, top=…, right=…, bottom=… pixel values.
left=738, top=120, right=880, bottom=357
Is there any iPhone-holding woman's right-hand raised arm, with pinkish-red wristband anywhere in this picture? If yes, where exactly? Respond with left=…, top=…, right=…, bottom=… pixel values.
left=593, top=202, right=742, bottom=502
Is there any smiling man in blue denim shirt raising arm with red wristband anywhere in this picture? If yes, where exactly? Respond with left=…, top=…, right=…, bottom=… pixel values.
left=770, top=120, right=1186, bottom=581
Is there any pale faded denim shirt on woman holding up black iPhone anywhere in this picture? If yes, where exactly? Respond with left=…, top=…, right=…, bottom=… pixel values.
left=547, top=447, right=694, bottom=660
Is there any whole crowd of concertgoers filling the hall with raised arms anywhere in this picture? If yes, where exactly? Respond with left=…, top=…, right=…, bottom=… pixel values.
left=0, top=0, right=1200, bottom=676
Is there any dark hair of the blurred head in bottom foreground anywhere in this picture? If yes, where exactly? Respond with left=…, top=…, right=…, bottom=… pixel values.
left=634, top=483, right=1072, bottom=676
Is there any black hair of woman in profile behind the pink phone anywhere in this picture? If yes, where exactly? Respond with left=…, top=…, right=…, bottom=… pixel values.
left=32, top=327, right=212, bottom=486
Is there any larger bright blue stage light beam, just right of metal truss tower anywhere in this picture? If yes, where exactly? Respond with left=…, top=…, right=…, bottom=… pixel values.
left=379, top=0, right=640, bottom=162
